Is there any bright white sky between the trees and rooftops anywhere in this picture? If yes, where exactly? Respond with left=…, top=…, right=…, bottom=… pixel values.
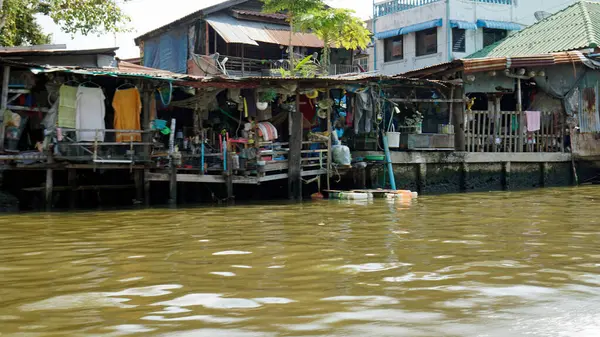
left=38, top=0, right=373, bottom=58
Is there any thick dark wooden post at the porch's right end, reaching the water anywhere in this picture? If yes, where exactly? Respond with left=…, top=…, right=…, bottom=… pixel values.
left=288, top=92, right=302, bottom=200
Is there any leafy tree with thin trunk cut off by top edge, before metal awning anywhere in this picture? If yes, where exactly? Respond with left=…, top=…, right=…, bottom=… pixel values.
left=262, top=0, right=325, bottom=64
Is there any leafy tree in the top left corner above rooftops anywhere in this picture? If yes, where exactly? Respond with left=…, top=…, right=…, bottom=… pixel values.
left=0, top=0, right=130, bottom=46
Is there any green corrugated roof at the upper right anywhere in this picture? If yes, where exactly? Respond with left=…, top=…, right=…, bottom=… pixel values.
left=467, top=0, right=600, bottom=58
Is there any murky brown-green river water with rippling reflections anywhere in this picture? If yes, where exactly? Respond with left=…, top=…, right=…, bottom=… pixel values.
left=0, top=187, right=600, bottom=337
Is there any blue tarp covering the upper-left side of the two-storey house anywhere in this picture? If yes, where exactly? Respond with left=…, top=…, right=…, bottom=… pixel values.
left=144, top=28, right=188, bottom=74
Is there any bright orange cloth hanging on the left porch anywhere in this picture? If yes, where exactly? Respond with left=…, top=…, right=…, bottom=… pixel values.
left=112, top=88, right=142, bottom=142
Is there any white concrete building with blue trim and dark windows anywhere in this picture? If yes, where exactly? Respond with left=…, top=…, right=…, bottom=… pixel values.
left=370, top=0, right=592, bottom=74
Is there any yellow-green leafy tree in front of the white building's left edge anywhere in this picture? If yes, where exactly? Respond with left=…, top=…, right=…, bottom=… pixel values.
left=297, top=8, right=371, bottom=69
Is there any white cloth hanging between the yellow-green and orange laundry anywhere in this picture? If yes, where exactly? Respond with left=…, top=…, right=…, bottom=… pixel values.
left=76, top=86, right=106, bottom=142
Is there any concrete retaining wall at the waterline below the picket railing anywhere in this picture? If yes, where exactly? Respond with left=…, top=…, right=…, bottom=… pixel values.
left=353, top=152, right=573, bottom=194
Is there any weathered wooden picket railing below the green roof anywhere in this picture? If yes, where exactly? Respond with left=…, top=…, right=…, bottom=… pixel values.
left=465, top=111, right=565, bottom=152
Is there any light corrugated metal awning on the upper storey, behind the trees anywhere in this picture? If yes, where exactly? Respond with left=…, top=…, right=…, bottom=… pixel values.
left=206, top=14, right=323, bottom=48
